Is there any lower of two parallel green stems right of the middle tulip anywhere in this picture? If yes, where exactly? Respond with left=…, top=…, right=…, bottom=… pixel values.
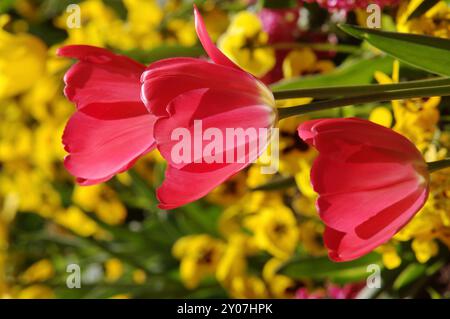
left=278, top=85, right=450, bottom=119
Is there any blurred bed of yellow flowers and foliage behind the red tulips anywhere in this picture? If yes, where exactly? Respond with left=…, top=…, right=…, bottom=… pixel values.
left=0, top=0, right=450, bottom=298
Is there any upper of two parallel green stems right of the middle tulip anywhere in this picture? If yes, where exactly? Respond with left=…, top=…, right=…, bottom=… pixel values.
left=273, top=78, right=450, bottom=100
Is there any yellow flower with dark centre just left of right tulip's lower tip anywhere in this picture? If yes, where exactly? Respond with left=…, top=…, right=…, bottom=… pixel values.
left=245, top=205, right=298, bottom=259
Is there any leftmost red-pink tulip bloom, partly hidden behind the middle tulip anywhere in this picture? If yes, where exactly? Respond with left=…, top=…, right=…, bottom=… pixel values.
left=58, top=45, right=156, bottom=185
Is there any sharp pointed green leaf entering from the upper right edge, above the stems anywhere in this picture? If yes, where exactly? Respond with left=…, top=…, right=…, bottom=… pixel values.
left=340, top=25, right=450, bottom=76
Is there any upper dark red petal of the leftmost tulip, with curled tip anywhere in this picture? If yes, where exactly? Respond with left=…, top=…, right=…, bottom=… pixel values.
left=58, top=45, right=147, bottom=118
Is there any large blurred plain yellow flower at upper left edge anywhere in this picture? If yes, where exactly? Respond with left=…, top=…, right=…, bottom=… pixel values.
left=0, top=15, right=47, bottom=99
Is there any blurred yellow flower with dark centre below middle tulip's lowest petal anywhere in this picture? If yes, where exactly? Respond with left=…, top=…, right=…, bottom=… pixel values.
left=172, top=235, right=224, bottom=289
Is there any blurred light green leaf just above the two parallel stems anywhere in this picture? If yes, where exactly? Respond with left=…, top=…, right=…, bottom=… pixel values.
left=271, top=56, right=393, bottom=91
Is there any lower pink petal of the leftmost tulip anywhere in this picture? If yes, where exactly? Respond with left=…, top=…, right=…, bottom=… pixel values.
left=63, top=111, right=155, bottom=185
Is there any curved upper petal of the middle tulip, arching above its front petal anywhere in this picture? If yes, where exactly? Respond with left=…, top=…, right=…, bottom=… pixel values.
left=141, top=58, right=267, bottom=116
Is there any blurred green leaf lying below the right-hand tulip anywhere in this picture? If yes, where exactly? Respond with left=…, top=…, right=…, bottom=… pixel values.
left=279, top=253, right=381, bottom=283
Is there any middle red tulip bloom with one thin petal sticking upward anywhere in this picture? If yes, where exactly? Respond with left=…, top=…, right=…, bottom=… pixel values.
left=142, top=8, right=276, bottom=209
